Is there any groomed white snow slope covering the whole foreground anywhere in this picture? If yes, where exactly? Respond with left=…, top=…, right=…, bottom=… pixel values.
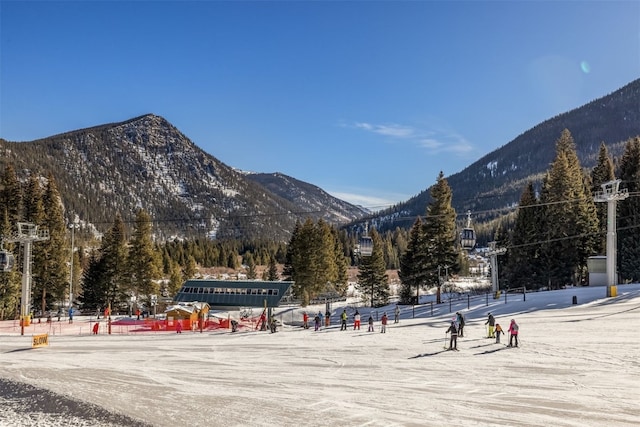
left=0, top=284, right=640, bottom=427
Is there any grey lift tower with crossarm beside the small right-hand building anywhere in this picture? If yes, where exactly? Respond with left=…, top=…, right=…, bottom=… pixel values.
left=594, top=179, right=629, bottom=297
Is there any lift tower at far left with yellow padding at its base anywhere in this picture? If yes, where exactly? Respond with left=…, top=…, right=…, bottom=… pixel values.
left=6, top=222, right=49, bottom=335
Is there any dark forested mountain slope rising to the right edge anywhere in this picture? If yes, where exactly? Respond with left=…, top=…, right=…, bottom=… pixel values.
left=371, top=79, right=640, bottom=236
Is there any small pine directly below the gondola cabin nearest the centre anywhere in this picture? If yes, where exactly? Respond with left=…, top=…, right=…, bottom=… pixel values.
left=357, top=228, right=389, bottom=307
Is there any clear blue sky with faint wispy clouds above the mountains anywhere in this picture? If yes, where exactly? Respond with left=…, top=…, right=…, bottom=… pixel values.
left=0, top=0, right=640, bottom=209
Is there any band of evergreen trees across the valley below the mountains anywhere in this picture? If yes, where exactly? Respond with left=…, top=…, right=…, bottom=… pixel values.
left=0, top=130, right=640, bottom=319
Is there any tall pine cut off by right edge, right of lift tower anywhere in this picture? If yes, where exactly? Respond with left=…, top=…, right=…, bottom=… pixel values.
left=617, top=137, right=640, bottom=282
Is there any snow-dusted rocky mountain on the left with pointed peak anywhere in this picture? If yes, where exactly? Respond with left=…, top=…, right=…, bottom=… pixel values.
left=0, top=114, right=365, bottom=241
